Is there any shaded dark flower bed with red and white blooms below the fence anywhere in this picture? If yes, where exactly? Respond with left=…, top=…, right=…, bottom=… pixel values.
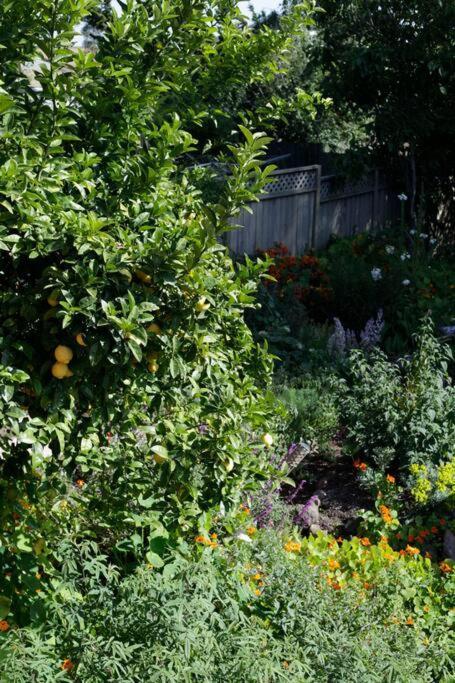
left=250, top=227, right=455, bottom=358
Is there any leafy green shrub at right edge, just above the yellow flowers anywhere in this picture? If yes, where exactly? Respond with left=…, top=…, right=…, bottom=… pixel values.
left=340, top=319, right=455, bottom=502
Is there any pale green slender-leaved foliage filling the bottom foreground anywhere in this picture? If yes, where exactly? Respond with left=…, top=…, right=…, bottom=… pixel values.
left=0, top=531, right=454, bottom=683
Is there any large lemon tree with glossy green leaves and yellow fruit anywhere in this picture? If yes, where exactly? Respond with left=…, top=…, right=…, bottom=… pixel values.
left=0, top=0, right=314, bottom=620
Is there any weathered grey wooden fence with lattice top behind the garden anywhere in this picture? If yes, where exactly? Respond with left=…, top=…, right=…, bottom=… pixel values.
left=223, top=165, right=399, bottom=254
